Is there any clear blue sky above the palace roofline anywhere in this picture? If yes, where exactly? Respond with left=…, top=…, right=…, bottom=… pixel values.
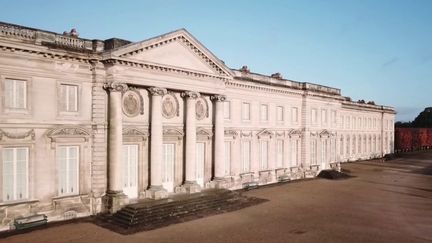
left=0, top=0, right=432, bottom=121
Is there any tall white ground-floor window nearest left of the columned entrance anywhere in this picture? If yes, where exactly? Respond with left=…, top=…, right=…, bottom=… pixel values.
left=57, top=146, right=79, bottom=195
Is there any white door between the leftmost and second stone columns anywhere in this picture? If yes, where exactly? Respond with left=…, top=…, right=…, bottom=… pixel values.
left=122, top=145, right=138, bottom=199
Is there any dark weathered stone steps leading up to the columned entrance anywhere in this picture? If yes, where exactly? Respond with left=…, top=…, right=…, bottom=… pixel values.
left=98, top=189, right=267, bottom=234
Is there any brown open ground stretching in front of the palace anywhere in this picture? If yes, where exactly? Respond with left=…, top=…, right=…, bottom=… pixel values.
left=0, top=152, right=432, bottom=243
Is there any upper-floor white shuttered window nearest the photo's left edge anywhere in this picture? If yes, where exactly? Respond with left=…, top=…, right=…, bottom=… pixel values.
left=4, top=79, right=27, bottom=109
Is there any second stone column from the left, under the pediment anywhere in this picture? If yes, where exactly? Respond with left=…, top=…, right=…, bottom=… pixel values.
left=146, top=87, right=168, bottom=199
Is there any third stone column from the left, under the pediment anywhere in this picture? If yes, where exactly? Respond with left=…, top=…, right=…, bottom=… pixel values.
left=181, top=91, right=201, bottom=193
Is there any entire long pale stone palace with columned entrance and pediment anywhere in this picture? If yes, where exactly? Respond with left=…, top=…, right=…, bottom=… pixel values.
left=0, top=22, right=395, bottom=229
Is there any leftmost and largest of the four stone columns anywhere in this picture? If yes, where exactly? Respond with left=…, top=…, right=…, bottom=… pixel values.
left=104, top=82, right=128, bottom=213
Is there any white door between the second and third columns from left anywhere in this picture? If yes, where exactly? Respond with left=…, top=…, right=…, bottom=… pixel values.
left=162, top=143, right=175, bottom=192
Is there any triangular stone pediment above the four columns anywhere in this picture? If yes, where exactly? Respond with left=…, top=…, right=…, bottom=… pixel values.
left=110, top=29, right=235, bottom=77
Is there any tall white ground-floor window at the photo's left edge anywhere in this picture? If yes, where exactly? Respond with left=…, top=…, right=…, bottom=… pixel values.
left=3, top=147, right=29, bottom=201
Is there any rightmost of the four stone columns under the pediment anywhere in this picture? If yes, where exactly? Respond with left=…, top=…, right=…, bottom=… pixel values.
left=211, top=95, right=229, bottom=188
